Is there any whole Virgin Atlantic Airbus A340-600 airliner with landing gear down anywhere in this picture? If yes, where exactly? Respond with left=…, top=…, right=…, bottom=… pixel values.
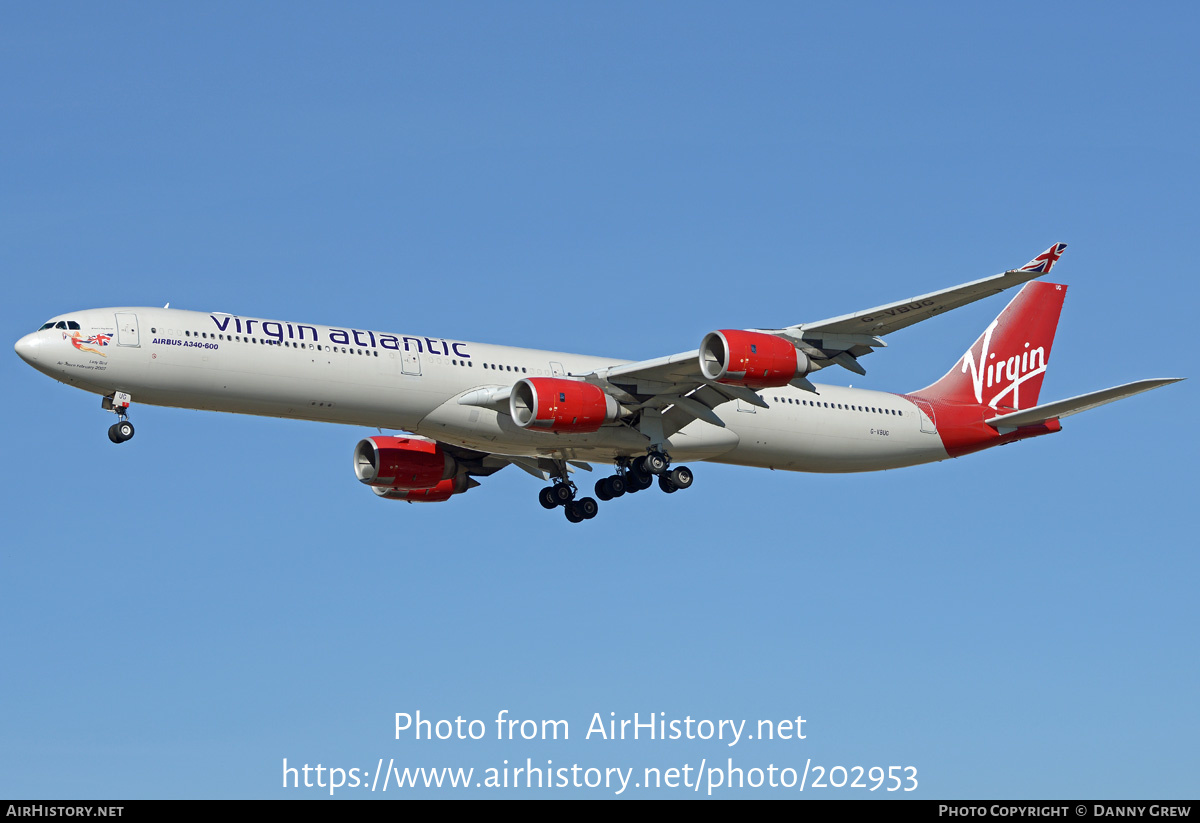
left=16, top=244, right=1182, bottom=523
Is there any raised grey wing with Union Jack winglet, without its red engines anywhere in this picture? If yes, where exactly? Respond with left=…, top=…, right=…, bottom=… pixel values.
left=577, top=242, right=1067, bottom=434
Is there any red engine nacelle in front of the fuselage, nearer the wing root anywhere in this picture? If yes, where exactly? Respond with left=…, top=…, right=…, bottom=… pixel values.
left=509, top=377, right=620, bottom=434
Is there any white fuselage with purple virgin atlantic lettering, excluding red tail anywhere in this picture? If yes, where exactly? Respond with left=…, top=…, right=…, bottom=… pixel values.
left=17, top=308, right=948, bottom=471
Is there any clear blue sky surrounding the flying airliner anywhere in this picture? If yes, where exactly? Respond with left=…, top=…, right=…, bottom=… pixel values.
left=0, top=4, right=1200, bottom=798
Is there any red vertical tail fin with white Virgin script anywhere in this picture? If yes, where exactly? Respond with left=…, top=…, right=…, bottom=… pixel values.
left=912, top=282, right=1067, bottom=410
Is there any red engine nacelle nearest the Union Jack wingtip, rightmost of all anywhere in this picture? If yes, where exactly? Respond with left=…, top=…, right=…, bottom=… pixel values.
left=700, top=329, right=812, bottom=389
